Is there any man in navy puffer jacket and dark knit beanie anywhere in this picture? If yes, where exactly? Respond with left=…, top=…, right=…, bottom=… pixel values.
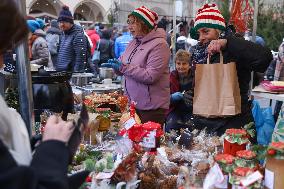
left=55, top=6, right=88, bottom=72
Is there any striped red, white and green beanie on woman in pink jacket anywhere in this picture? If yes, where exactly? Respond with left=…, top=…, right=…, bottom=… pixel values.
left=128, top=6, right=158, bottom=29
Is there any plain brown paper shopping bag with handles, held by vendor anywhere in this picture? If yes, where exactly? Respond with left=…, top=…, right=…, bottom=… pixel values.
left=193, top=53, right=241, bottom=118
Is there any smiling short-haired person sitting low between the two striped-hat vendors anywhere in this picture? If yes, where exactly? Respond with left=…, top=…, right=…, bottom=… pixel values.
left=166, top=49, right=194, bottom=132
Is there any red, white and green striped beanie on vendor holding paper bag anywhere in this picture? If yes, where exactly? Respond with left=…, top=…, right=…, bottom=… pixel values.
left=194, top=4, right=226, bottom=31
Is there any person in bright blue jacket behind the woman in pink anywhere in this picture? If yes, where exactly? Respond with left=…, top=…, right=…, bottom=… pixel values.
left=114, top=26, right=133, bottom=58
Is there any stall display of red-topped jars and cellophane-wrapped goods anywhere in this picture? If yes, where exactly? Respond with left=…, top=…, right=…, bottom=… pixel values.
left=30, top=92, right=283, bottom=189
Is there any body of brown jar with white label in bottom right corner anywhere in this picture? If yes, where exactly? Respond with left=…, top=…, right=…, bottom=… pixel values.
left=264, top=157, right=284, bottom=189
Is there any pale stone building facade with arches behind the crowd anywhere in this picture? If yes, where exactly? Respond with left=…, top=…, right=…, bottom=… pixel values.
left=26, top=0, right=283, bottom=24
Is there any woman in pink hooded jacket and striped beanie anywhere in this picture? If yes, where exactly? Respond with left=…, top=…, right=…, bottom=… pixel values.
left=102, top=6, right=170, bottom=124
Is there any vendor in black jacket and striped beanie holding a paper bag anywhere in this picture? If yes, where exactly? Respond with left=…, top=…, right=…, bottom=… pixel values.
left=191, top=4, right=272, bottom=135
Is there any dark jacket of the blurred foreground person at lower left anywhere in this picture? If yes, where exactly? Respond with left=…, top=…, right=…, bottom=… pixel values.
left=0, top=140, right=88, bottom=189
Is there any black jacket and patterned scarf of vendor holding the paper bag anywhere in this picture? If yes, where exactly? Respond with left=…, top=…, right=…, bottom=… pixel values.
left=192, top=36, right=272, bottom=136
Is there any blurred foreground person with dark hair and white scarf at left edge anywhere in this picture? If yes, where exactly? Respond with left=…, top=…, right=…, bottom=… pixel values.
left=0, top=0, right=88, bottom=189
